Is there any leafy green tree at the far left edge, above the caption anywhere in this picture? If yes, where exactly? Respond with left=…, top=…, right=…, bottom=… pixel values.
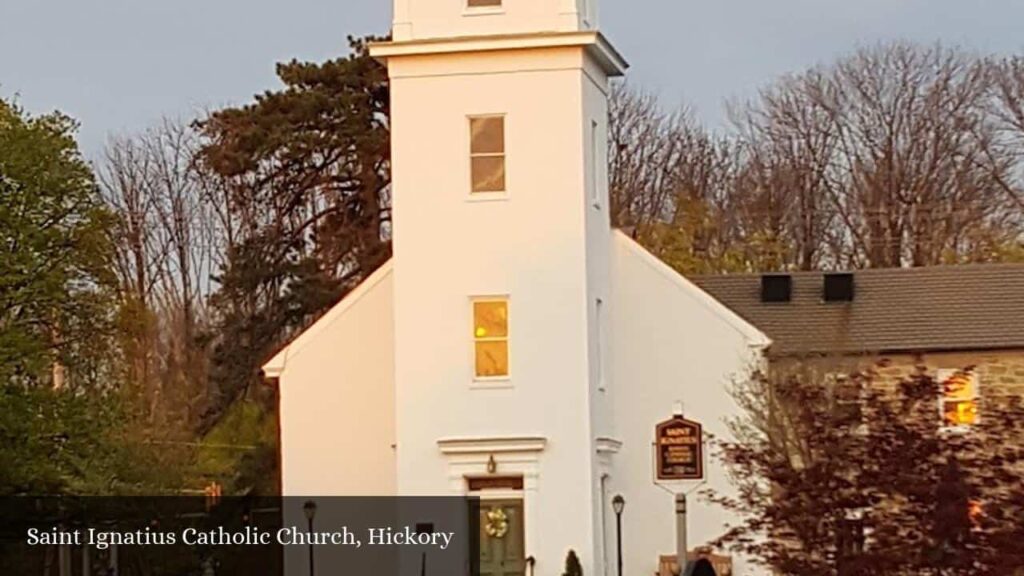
left=0, top=100, right=180, bottom=494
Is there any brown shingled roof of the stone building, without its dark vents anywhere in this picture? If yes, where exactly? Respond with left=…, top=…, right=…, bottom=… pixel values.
left=690, top=264, right=1024, bottom=355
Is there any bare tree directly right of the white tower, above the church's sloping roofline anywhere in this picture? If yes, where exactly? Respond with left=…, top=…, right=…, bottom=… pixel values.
left=608, top=86, right=742, bottom=273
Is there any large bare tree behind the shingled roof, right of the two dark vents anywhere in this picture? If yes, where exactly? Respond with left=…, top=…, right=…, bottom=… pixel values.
left=825, top=44, right=1019, bottom=266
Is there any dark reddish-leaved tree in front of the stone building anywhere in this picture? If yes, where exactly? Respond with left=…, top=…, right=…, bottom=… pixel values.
left=711, top=364, right=1024, bottom=576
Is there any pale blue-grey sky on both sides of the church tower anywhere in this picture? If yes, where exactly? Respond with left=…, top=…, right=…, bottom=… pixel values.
left=0, top=0, right=1024, bottom=158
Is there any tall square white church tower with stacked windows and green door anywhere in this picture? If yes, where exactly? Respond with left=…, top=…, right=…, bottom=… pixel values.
left=371, top=0, right=626, bottom=576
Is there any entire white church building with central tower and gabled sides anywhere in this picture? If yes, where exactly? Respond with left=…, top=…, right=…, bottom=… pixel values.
left=264, top=0, right=769, bottom=576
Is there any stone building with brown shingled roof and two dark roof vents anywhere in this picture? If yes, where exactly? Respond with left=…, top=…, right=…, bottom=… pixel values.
left=694, top=264, right=1024, bottom=426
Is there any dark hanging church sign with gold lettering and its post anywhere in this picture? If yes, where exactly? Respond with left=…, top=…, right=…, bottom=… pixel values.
left=654, top=410, right=705, bottom=574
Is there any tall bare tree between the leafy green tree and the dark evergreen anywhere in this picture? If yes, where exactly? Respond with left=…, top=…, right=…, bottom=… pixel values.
left=99, top=120, right=227, bottom=421
